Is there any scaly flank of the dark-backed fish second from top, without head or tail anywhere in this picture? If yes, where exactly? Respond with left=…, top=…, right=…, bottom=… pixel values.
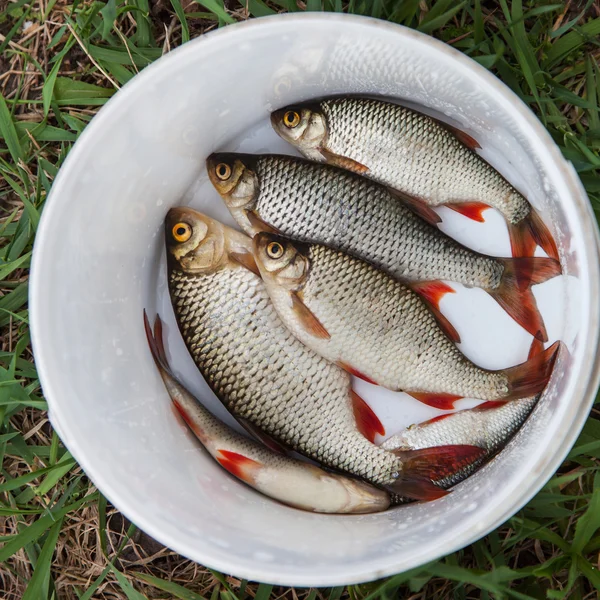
left=254, top=155, right=504, bottom=290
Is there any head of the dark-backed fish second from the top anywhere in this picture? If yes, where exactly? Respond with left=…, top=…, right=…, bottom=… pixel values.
left=206, top=152, right=259, bottom=233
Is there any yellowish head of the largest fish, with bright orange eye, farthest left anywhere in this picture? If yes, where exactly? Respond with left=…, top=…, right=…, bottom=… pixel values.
left=165, top=206, right=229, bottom=274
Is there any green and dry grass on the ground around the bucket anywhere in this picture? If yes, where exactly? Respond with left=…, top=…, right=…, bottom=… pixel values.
left=0, top=0, right=600, bottom=600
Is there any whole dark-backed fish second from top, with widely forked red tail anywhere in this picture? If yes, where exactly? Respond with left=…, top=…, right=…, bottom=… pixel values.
left=206, top=153, right=561, bottom=342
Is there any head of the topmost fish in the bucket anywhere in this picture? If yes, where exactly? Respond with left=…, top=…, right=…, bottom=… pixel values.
left=271, top=104, right=327, bottom=162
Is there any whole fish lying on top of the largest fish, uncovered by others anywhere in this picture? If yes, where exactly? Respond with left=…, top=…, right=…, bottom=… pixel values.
left=253, top=232, right=560, bottom=409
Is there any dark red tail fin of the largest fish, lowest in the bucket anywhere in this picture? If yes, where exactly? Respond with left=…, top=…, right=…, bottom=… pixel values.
left=390, top=444, right=486, bottom=500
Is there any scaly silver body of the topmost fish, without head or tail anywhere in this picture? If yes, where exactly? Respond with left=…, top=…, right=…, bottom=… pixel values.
left=319, top=98, right=530, bottom=223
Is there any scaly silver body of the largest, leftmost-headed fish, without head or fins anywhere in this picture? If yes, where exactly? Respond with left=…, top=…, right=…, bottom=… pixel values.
left=169, top=267, right=402, bottom=485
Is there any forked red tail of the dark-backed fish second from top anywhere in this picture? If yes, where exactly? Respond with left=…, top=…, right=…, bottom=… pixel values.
left=489, top=256, right=561, bottom=342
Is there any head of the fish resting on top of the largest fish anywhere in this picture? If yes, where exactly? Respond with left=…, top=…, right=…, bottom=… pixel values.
left=252, top=232, right=310, bottom=291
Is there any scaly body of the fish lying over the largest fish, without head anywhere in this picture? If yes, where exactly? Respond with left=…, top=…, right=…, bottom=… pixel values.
left=296, top=245, right=509, bottom=400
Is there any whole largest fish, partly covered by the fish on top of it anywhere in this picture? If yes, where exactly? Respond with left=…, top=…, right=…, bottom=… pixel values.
left=165, top=207, right=482, bottom=500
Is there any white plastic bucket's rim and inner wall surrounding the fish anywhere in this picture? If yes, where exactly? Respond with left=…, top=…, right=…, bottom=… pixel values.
left=30, top=13, right=600, bottom=586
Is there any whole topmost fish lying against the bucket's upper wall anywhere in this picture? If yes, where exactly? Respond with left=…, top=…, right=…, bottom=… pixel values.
left=271, top=96, right=559, bottom=259
